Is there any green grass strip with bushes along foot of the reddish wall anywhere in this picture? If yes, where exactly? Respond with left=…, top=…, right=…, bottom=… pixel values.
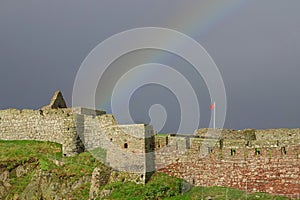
left=104, top=180, right=288, bottom=200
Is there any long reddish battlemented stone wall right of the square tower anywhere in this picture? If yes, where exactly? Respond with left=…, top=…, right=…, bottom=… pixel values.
left=156, top=130, right=300, bottom=197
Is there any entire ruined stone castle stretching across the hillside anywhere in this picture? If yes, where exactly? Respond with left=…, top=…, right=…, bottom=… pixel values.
left=0, top=92, right=300, bottom=198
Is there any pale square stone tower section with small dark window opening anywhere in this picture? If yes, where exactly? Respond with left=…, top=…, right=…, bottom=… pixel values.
left=74, top=109, right=155, bottom=183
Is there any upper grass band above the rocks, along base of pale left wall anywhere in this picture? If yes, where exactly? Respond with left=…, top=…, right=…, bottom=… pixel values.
left=0, top=140, right=107, bottom=176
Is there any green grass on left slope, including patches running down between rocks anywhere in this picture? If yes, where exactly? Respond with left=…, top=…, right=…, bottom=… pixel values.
left=0, top=140, right=109, bottom=199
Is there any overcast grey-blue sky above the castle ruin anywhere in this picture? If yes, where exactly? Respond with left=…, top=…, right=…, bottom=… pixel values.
left=0, top=0, right=300, bottom=132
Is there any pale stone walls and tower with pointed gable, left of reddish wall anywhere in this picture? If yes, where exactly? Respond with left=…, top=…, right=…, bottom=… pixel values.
left=0, top=91, right=155, bottom=183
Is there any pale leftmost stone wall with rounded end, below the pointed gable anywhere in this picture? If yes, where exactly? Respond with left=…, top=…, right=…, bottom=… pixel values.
left=0, top=109, right=82, bottom=155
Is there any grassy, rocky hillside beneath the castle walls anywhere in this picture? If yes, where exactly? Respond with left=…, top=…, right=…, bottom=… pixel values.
left=0, top=141, right=286, bottom=200
